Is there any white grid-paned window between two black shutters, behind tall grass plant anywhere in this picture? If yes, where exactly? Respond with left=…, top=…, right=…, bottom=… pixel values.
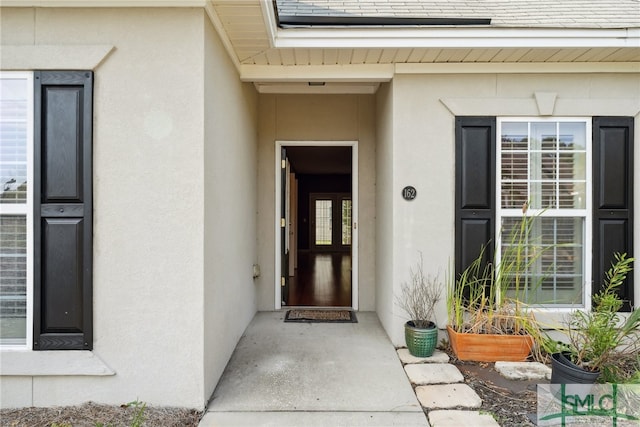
left=496, top=117, right=592, bottom=308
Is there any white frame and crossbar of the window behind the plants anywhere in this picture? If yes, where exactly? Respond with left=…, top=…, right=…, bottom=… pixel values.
left=495, top=116, right=593, bottom=313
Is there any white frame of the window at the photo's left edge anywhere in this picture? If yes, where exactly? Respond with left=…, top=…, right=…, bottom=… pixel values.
left=0, top=71, right=34, bottom=351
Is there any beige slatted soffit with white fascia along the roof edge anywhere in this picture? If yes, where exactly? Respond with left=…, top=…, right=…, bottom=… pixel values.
left=208, top=0, right=640, bottom=77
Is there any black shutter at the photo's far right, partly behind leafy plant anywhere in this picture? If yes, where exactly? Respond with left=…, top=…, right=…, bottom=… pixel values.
left=593, top=117, right=633, bottom=311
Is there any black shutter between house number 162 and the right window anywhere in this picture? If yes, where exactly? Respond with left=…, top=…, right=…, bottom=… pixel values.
left=455, top=117, right=496, bottom=284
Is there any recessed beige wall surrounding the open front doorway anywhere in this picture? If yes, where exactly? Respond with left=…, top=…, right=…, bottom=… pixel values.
left=258, top=95, right=376, bottom=311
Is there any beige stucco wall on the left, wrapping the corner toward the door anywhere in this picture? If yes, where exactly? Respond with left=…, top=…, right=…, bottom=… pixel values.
left=0, top=8, right=257, bottom=409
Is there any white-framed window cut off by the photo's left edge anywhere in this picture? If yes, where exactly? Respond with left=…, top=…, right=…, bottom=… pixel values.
left=0, top=72, right=33, bottom=349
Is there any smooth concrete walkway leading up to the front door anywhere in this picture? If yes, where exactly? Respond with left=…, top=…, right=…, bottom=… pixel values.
left=200, top=312, right=428, bottom=427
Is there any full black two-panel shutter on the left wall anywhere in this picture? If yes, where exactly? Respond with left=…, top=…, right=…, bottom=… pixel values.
left=33, top=71, right=93, bottom=350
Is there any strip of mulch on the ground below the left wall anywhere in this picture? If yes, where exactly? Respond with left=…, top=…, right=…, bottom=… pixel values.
left=0, top=402, right=203, bottom=427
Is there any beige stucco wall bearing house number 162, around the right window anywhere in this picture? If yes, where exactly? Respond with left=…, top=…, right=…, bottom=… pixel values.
left=377, top=73, right=640, bottom=345
